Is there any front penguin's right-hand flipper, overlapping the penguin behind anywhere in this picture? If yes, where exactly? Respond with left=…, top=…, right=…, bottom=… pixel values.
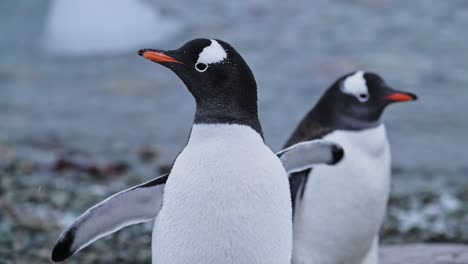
left=276, top=139, right=344, bottom=174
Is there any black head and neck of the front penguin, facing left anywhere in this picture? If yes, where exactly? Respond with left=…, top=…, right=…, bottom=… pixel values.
left=138, top=39, right=261, bottom=134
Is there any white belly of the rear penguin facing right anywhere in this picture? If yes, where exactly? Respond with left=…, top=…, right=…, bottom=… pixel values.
left=293, top=125, right=390, bottom=264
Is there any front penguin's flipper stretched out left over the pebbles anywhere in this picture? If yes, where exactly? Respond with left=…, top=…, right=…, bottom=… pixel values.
left=52, top=174, right=169, bottom=262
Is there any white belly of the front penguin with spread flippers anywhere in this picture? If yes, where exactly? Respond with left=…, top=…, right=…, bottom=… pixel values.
left=152, top=124, right=292, bottom=264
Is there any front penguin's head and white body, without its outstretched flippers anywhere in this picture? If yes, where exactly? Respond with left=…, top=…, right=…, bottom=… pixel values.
left=48, top=39, right=340, bottom=264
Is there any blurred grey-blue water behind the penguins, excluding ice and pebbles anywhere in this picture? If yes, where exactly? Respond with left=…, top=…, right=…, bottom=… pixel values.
left=0, top=0, right=468, bottom=252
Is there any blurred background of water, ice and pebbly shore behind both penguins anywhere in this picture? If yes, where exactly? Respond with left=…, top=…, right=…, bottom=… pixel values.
left=0, top=0, right=468, bottom=263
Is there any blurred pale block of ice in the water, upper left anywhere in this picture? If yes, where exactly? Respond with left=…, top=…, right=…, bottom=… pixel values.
left=43, top=0, right=181, bottom=56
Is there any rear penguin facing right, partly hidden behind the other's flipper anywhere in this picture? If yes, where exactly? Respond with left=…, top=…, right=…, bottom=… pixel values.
left=286, top=71, right=416, bottom=264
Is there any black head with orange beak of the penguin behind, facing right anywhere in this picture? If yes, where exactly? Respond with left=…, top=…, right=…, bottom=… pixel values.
left=312, top=71, right=417, bottom=130
